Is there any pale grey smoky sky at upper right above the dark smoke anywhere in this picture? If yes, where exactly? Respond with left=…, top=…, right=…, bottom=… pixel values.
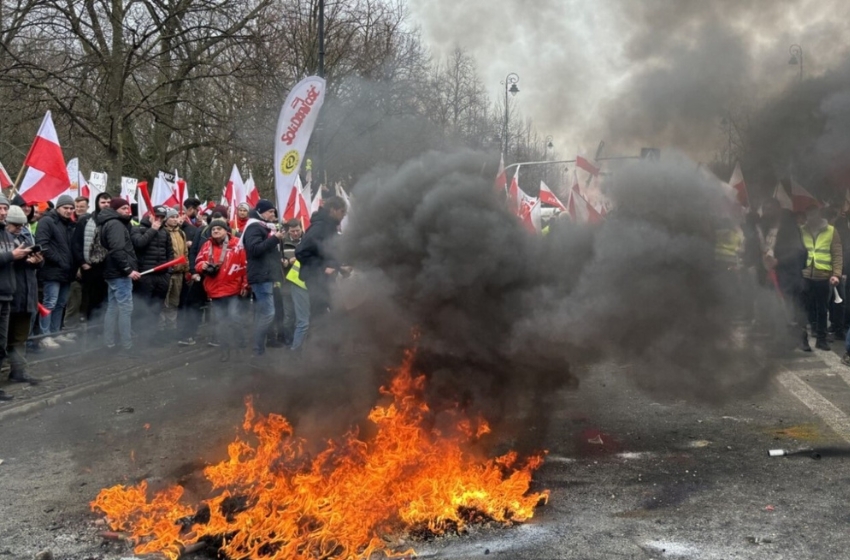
left=412, top=0, right=850, bottom=161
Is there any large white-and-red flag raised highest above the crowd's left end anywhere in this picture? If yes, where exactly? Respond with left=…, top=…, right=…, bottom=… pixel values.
left=18, top=111, right=71, bottom=203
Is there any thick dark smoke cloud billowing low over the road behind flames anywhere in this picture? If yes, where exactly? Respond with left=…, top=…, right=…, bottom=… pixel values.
left=294, top=153, right=771, bottom=446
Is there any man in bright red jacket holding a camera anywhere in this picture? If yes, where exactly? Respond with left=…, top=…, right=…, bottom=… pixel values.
left=195, top=218, right=248, bottom=362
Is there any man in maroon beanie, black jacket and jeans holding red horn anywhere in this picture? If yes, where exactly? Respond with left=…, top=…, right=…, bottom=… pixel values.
left=97, top=198, right=141, bottom=352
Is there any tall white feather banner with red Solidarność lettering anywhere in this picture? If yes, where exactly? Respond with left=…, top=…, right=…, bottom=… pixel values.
left=274, top=76, right=325, bottom=220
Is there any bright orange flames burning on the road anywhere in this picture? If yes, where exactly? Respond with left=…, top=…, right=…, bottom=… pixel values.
left=91, top=352, right=548, bottom=559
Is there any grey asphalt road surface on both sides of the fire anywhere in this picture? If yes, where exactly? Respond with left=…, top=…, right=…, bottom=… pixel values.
left=0, top=340, right=850, bottom=560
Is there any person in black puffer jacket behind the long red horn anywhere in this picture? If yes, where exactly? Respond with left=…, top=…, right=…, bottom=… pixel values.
left=130, top=206, right=174, bottom=334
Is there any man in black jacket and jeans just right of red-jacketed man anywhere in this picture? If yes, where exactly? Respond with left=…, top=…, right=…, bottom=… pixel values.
left=241, top=199, right=284, bottom=356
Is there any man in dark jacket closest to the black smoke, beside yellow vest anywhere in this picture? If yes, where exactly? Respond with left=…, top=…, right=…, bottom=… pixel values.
left=295, top=196, right=348, bottom=322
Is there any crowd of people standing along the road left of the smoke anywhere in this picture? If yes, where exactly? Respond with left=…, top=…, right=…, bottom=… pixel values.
left=0, top=193, right=351, bottom=400
